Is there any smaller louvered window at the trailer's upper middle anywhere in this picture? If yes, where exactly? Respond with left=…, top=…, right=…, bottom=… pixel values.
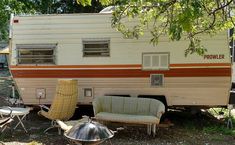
left=82, top=40, right=110, bottom=57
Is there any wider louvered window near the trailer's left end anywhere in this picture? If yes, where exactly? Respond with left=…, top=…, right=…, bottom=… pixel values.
left=16, top=45, right=56, bottom=64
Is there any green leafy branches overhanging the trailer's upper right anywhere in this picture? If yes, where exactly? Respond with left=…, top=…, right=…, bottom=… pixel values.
left=77, top=0, right=234, bottom=55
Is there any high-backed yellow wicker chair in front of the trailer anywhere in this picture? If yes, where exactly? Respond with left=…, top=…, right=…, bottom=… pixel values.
left=38, top=79, right=78, bottom=134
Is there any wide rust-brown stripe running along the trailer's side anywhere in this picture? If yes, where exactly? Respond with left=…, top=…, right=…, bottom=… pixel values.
left=11, top=68, right=231, bottom=78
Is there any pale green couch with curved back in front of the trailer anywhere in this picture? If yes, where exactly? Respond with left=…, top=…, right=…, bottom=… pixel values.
left=92, top=96, right=165, bottom=136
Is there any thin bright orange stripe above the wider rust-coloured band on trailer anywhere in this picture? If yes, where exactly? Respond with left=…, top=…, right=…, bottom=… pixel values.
left=10, top=63, right=231, bottom=68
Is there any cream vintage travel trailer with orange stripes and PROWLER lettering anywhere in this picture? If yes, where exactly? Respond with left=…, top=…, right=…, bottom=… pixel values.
left=9, top=14, right=232, bottom=107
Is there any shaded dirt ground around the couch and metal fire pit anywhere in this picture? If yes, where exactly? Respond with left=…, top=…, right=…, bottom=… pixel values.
left=0, top=105, right=235, bottom=145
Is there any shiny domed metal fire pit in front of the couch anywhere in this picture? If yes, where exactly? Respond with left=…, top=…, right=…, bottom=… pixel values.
left=64, top=119, right=115, bottom=145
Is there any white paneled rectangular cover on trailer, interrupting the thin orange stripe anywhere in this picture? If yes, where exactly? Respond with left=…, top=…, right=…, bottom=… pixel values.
left=142, top=53, right=169, bottom=70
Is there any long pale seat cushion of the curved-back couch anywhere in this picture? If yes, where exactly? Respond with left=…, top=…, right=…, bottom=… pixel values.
left=95, top=112, right=160, bottom=124
